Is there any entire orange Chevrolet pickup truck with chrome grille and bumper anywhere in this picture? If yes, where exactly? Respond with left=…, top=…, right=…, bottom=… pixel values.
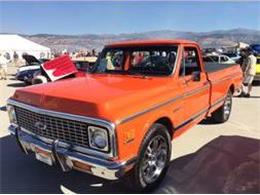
left=7, top=40, right=242, bottom=191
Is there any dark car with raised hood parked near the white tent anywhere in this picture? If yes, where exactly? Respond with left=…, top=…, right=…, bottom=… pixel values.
left=15, top=55, right=49, bottom=84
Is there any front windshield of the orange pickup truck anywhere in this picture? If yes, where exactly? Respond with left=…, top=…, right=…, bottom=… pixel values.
left=90, top=46, right=178, bottom=76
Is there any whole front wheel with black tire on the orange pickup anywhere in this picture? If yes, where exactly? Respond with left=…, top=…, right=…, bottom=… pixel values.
left=124, top=123, right=171, bottom=192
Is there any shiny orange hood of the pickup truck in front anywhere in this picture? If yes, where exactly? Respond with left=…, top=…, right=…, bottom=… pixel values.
left=12, top=74, right=175, bottom=122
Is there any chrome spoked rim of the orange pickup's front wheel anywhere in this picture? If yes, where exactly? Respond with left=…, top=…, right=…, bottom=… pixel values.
left=140, top=135, right=169, bottom=184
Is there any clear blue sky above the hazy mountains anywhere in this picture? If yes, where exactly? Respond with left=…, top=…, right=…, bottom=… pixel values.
left=0, top=1, right=260, bottom=34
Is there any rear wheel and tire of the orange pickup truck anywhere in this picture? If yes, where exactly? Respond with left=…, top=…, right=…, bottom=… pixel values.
left=212, top=90, right=232, bottom=123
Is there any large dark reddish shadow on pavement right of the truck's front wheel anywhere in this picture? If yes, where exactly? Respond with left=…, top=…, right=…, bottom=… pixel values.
left=156, top=136, right=260, bottom=193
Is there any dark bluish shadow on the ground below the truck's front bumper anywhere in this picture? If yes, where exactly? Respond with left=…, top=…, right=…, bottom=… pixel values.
left=0, top=136, right=127, bottom=194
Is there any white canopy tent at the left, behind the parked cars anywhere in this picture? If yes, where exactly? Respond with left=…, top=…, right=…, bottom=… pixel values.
left=0, top=34, right=51, bottom=59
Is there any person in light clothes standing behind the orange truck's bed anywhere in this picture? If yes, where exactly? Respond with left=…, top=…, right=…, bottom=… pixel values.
left=241, top=48, right=256, bottom=97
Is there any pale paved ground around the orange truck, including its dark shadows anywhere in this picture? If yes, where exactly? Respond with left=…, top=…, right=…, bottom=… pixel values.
left=0, top=68, right=260, bottom=193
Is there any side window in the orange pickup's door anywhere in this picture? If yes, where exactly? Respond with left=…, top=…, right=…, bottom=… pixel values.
left=179, top=47, right=201, bottom=76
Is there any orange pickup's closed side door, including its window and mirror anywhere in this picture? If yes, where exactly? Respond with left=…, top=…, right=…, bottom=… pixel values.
left=179, top=47, right=210, bottom=123
